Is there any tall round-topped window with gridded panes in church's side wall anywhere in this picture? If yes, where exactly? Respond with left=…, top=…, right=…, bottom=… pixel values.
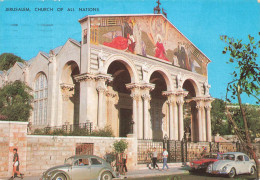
left=33, top=73, right=48, bottom=125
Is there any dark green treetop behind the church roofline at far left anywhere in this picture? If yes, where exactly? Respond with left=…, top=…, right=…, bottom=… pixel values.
left=0, top=53, right=24, bottom=71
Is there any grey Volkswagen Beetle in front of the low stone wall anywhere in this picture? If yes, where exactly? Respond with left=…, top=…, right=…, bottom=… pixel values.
left=40, top=155, right=117, bottom=180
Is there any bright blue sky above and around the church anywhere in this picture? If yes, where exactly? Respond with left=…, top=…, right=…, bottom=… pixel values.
left=0, top=0, right=260, bottom=104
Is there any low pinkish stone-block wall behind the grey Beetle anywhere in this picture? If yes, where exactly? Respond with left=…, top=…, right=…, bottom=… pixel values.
left=0, top=121, right=137, bottom=177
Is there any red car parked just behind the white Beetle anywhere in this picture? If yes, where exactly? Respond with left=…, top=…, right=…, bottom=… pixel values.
left=189, top=153, right=221, bottom=172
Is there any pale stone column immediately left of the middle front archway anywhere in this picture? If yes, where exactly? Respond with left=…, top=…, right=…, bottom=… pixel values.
left=141, top=83, right=155, bottom=139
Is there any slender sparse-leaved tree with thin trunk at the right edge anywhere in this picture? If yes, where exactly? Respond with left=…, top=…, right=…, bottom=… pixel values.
left=220, top=33, right=260, bottom=179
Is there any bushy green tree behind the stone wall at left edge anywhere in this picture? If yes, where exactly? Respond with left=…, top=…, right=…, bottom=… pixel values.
left=0, top=81, right=33, bottom=121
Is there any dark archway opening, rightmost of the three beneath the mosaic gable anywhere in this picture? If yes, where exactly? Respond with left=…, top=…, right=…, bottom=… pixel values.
left=182, top=79, right=199, bottom=141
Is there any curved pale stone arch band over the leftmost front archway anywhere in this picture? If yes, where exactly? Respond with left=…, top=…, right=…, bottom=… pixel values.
left=104, top=55, right=139, bottom=83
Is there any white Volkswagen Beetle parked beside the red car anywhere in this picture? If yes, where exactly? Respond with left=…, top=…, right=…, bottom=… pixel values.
left=206, top=152, right=256, bottom=178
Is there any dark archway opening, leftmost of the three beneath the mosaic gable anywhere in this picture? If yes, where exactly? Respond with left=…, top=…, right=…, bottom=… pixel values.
left=107, top=61, right=133, bottom=137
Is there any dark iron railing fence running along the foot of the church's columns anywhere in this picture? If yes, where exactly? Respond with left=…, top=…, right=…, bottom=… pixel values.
left=137, top=139, right=247, bottom=164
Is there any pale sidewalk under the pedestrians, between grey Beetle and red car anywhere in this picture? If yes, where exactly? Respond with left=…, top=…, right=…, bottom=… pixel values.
left=114, top=163, right=188, bottom=180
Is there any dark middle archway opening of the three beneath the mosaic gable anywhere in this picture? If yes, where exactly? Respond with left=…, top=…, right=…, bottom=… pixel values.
left=150, top=71, right=167, bottom=139
